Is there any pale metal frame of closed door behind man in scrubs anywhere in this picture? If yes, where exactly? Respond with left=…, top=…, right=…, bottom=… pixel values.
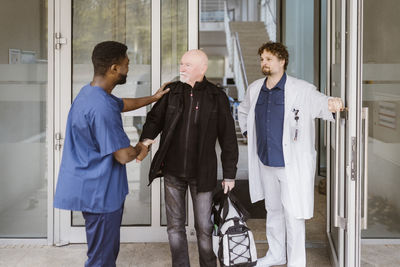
left=52, top=0, right=199, bottom=245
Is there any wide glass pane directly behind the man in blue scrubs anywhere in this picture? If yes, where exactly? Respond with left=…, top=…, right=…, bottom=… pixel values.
left=72, top=0, right=151, bottom=226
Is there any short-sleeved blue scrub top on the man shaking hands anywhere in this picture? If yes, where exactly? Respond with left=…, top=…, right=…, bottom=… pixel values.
left=54, top=84, right=130, bottom=213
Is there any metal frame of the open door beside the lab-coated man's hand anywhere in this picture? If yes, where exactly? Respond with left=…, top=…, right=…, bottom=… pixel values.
left=327, top=0, right=362, bottom=266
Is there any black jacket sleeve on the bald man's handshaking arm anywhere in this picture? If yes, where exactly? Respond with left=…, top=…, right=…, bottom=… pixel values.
left=140, top=92, right=170, bottom=141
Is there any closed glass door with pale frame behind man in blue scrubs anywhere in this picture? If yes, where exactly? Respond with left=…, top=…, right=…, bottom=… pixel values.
left=55, top=0, right=197, bottom=245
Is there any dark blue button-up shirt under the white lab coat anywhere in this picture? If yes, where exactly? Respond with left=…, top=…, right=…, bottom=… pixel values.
left=255, top=73, right=286, bottom=167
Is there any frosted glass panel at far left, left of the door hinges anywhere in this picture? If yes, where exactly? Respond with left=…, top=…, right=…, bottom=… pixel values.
left=0, top=0, right=48, bottom=238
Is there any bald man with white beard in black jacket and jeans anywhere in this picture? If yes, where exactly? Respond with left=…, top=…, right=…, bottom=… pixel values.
left=140, top=50, right=238, bottom=267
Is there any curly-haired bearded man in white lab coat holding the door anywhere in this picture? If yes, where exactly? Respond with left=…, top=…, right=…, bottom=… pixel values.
left=238, top=42, right=343, bottom=266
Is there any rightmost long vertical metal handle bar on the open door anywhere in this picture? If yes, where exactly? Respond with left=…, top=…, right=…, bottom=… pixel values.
left=361, top=107, right=369, bottom=230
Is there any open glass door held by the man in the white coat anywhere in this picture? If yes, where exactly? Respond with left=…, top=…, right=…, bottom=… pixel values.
left=327, top=0, right=363, bottom=266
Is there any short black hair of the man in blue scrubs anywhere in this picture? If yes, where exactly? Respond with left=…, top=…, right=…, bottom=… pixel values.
left=92, top=41, right=128, bottom=76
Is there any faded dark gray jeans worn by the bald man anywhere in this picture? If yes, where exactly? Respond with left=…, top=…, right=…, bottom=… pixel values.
left=164, top=175, right=217, bottom=267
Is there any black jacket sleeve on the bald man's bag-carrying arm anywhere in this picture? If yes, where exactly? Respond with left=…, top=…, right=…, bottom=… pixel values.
left=218, top=92, right=239, bottom=179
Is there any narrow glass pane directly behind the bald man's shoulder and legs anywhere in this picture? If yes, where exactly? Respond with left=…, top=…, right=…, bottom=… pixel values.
left=160, top=0, right=188, bottom=225
